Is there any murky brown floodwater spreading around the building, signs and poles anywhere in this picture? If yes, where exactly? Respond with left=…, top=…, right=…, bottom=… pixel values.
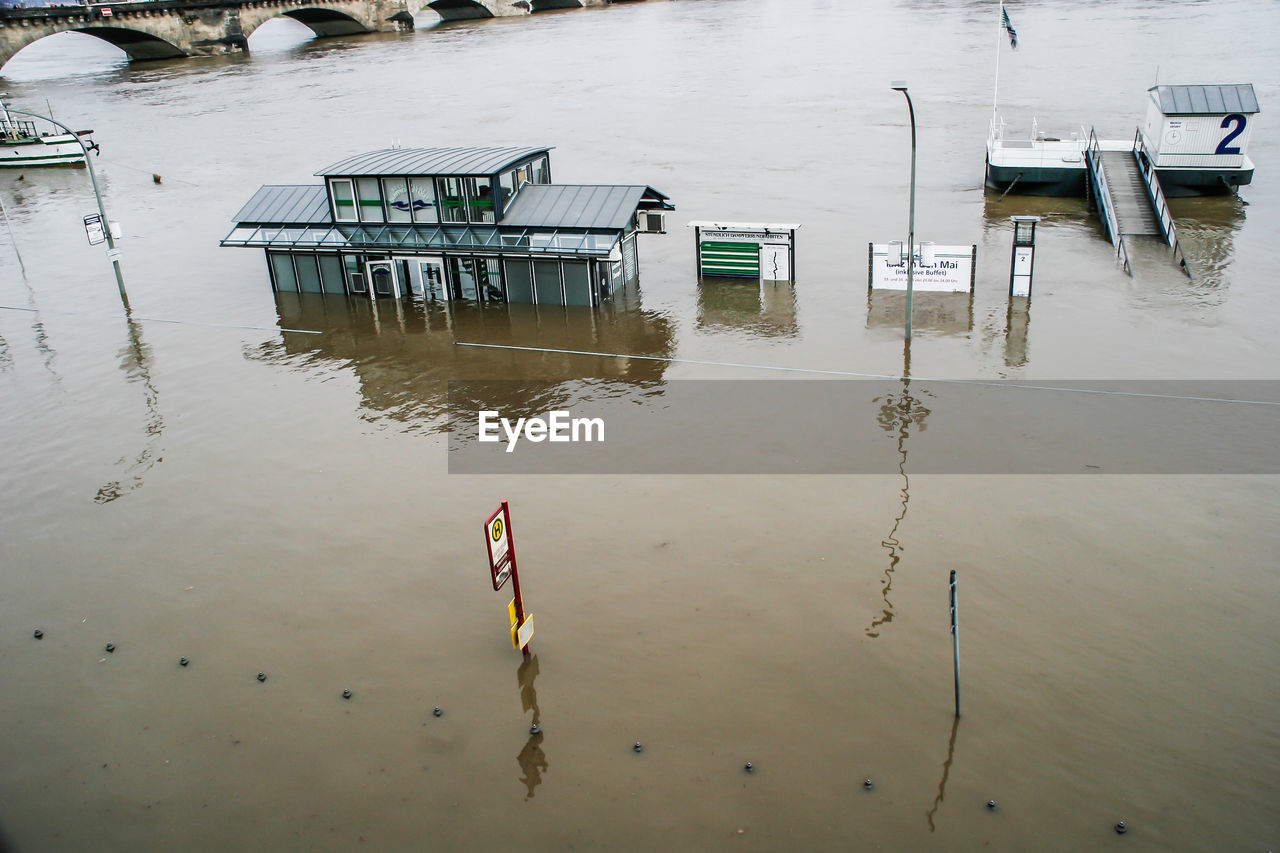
left=0, top=0, right=1280, bottom=852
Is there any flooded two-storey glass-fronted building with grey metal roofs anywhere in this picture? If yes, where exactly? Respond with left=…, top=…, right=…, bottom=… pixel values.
left=221, top=147, right=675, bottom=305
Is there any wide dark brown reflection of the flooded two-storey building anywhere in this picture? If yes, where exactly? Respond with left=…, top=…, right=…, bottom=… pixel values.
left=254, top=288, right=676, bottom=432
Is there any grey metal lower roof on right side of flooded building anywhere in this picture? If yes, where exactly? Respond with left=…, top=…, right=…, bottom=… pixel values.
left=502, top=183, right=671, bottom=229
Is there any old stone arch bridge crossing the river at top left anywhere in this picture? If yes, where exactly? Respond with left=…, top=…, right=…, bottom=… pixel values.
left=0, top=0, right=629, bottom=67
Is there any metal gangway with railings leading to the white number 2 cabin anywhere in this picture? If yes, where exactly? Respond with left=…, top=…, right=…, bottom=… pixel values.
left=1084, top=128, right=1192, bottom=278
